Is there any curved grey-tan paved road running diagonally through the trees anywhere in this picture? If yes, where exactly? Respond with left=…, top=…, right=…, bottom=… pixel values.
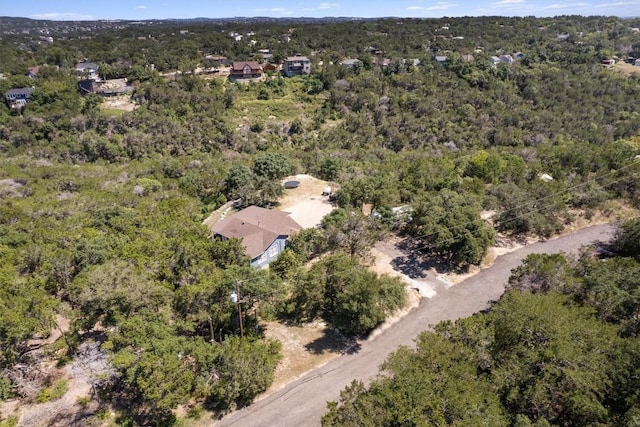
left=216, top=225, right=613, bottom=427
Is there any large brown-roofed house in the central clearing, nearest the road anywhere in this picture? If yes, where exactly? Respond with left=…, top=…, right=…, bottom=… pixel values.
left=211, top=206, right=302, bottom=268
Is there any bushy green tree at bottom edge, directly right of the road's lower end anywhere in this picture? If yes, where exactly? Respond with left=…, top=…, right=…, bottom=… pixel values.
left=322, top=333, right=509, bottom=426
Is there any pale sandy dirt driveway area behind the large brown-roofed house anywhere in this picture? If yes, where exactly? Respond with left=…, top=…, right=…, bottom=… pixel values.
left=278, top=175, right=335, bottom=228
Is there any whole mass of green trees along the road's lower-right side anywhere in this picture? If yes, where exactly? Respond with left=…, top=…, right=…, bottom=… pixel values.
left=322, top=219, right=640, bottom=426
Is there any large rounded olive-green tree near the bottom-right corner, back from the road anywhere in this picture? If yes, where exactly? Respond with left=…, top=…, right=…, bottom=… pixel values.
left=489, top=291, right=619, bottom=425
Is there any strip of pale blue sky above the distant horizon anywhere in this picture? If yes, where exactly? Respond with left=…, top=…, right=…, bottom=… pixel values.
left=0, top=0, right=640, bottom=20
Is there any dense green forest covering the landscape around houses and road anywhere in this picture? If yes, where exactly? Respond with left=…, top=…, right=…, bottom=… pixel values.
left=0, top=16, right=640, bottom=426
